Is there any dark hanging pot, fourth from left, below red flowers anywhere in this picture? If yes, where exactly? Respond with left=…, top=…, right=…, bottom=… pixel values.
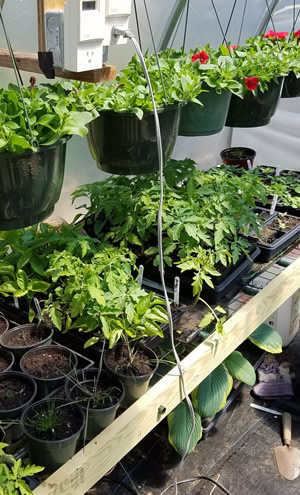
left=226, top=78, right=283, bottom=127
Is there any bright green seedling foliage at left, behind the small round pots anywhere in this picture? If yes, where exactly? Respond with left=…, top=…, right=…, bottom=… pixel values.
left=0, top=224, right=168, bottom=348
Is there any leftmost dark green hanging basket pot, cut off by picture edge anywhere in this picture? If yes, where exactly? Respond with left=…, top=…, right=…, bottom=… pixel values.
left=0, top=139, right=67, bottom=231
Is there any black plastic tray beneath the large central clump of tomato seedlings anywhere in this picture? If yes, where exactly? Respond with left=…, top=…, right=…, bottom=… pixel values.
left=144, top=246, right=260, bottom=304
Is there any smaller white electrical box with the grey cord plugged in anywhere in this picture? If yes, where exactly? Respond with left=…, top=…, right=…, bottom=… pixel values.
left=104, top=0, right=132, bottom=46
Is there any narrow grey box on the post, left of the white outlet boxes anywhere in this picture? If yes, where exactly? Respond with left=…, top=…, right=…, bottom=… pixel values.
left=45, top=10, right=64, bottom=67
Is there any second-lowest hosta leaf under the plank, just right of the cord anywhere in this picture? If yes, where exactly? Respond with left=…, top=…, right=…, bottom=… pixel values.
left=193, top=364, right=233, bottom=418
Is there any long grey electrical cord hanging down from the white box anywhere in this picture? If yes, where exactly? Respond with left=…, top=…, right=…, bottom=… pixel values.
left=114, top=28, right=196, bottom=495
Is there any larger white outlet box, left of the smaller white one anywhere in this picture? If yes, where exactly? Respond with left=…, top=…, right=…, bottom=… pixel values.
left=64, top=0, right=106, bottom=72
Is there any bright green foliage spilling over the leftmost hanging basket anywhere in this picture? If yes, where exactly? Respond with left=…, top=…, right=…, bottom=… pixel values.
left=0, top=81, right=96, bottom=153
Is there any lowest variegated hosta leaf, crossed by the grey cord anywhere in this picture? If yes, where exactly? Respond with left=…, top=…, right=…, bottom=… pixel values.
left=168, top=401, right=202, bottom=456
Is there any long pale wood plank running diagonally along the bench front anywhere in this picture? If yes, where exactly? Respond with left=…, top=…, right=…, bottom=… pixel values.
left=34, top=258, right=300, bottom=495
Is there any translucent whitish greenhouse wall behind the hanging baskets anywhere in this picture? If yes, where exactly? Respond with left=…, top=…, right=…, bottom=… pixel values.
left=0, top=0, right=300, bottom=220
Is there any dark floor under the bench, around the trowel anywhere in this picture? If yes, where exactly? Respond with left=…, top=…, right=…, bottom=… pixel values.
left=89, top=334, right=300, bottom=495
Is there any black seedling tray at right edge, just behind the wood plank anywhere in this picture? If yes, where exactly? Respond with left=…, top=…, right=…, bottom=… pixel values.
left=250, top=215, right=300, bottom=263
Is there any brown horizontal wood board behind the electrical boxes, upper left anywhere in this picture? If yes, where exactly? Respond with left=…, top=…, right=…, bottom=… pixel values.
left=0, top=48, right=117, bottom=83
